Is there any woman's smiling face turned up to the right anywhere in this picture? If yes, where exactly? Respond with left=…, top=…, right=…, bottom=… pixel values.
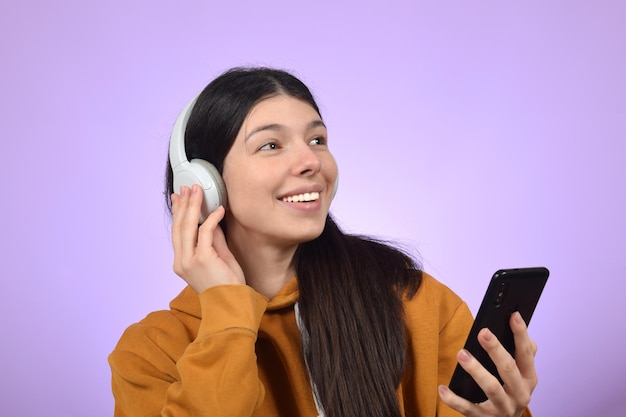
left=222, top=95, right=337, bottom=245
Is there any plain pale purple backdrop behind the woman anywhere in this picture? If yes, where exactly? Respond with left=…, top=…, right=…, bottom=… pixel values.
left=0, top=0, right=626, bottom=417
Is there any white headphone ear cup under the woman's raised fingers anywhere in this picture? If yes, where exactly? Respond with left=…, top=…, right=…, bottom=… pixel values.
left=174, top=159, right=227, bottom=224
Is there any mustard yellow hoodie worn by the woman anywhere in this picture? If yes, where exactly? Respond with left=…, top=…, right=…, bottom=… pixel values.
left=109, top=274, right=530, bottom=417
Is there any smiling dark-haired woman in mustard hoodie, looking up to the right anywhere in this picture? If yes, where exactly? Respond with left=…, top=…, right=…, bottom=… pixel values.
left=109, top=68, right=536, bottom=417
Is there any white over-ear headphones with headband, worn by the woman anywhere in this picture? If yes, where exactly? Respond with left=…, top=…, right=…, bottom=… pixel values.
left=170, top=97, right=227, bottom=223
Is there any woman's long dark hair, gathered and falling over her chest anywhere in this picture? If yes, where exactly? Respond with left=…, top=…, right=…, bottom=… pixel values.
left=165, top=68, right=421, bottom=417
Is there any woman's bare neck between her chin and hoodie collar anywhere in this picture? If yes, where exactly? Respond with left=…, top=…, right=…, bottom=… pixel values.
left=227, top=226, right=298, bottom=299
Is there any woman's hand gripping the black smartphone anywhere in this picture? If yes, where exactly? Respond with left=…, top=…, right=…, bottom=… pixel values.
left=439, top=312, right=537, bottom=417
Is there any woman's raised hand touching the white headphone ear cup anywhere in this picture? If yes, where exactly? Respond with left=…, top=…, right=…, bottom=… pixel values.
left=172, top=185, right=246, bottom=294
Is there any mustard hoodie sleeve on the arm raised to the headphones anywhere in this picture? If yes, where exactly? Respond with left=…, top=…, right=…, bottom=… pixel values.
left=109, top=285, right=267, bottom=417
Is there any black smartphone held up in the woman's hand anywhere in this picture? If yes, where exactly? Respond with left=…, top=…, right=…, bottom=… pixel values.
left=449, top=267, right=550, bottom=403
